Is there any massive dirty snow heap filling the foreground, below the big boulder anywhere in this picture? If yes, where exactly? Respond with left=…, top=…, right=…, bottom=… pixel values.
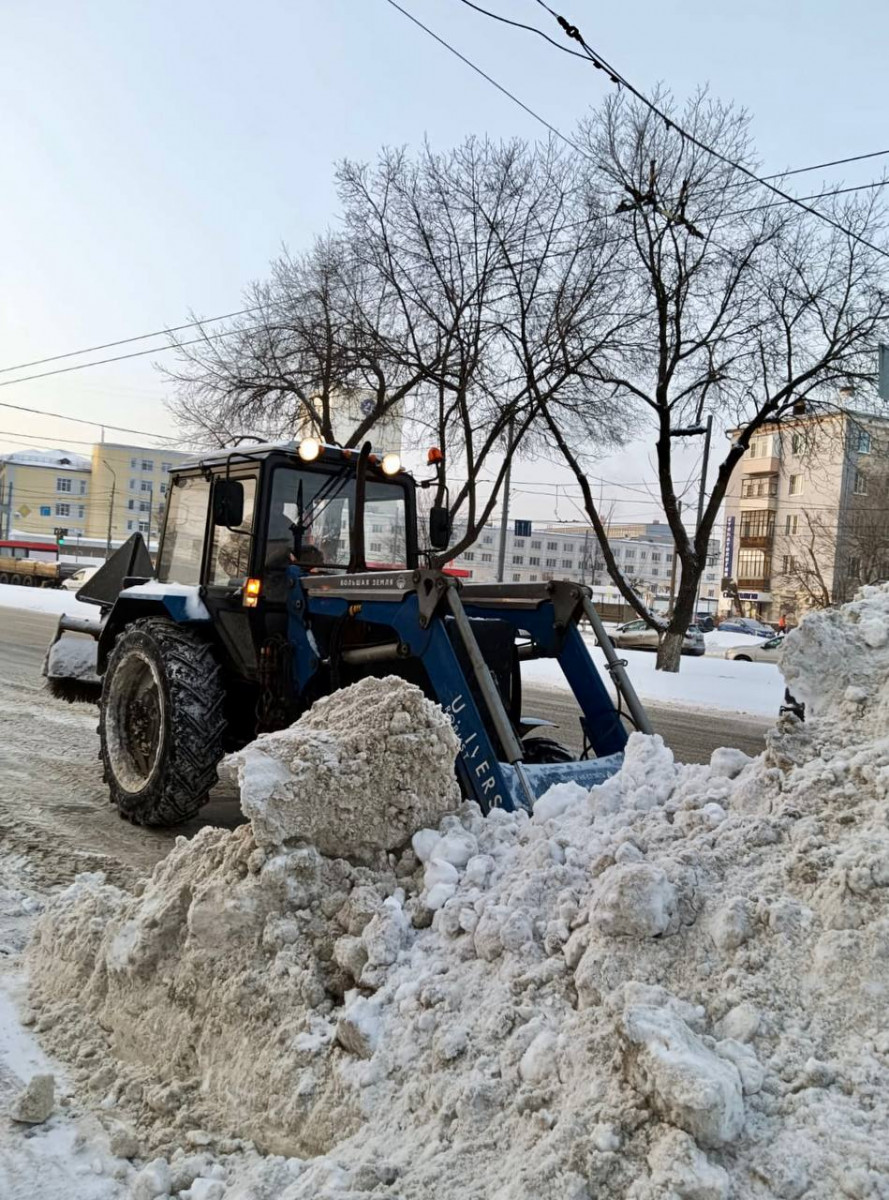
left=20, top=587, right=889, bottom=1200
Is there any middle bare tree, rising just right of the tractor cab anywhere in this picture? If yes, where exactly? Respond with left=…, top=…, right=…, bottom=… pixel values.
left=340, top=139, right=619, bottom=560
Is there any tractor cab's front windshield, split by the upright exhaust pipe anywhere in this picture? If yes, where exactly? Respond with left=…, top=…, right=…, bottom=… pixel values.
left=265, top=467, right=408, bottom=570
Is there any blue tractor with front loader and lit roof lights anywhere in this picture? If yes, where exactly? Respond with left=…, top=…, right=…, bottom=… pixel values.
left=44, top=438, right=650, bottom=826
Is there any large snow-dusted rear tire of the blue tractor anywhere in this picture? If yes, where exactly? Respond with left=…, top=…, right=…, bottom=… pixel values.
left=98, top=617, right=226, bottom=826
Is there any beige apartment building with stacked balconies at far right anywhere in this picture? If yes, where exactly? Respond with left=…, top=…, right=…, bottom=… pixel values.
left=720, top=403, right=889, bottom=622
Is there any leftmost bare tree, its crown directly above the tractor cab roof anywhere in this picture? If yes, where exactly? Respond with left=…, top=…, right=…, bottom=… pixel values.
left=166, top=234, right=434, bottom=446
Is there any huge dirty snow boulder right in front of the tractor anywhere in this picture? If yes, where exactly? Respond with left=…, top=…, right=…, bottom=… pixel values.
left=233, top=676, right=459, bottom=862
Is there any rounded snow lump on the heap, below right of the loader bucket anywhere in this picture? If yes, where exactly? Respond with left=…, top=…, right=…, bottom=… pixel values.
left=589, top=863, right=679, bottom=937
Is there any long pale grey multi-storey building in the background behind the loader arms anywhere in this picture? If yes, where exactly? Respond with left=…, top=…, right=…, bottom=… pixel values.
left=453, top=521, right=719, bottom=611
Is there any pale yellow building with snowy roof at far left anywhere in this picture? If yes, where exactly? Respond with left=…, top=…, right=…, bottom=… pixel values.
left=0, top=442, right=193, bottom=542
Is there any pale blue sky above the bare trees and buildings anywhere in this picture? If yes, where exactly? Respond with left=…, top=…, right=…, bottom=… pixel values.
left=0, top=0, right=889, bottom=518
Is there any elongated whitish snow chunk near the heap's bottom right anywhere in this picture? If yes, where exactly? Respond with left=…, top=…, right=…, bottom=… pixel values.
left=620, top=1004, right=744, bottom=1147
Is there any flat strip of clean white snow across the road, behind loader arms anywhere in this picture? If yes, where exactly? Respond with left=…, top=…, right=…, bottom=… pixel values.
left=522, top=638, right=785, bottom=716
